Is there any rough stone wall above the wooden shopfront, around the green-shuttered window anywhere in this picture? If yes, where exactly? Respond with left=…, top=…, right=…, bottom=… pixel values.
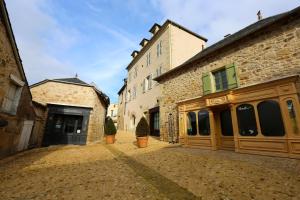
left=160, top=19, right=300, bottom=140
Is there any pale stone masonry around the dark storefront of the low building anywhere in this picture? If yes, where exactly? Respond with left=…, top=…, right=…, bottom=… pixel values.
left=31, top=81, right=106, bottom=143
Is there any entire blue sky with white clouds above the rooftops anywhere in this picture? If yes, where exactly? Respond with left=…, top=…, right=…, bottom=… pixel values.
left=6, top=0, right=300, bottom=102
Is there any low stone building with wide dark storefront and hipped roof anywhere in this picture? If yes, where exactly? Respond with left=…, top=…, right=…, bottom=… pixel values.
left=30, top=77, right=109, bottom=146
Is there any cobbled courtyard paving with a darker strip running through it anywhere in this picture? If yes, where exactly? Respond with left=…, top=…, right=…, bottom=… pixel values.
left=0, top=133, right=300, bottom=200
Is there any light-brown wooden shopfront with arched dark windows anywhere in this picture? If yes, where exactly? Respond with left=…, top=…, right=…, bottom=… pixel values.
left=178, top=76, right=300, bottom=158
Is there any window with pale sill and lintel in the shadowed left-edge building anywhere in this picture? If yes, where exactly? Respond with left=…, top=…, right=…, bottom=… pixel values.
left=2, top=74, right=25, bottom=115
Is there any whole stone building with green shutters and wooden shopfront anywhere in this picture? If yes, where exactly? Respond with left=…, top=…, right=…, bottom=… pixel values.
left=155, top=7, right=300, bottom=157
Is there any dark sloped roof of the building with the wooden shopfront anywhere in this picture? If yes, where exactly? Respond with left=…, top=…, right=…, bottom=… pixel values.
left=154, top=6, right=300, bottom=81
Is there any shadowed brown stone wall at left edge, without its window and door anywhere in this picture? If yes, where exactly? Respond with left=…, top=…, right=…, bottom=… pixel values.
left=0, top=15, right=35, bottom=158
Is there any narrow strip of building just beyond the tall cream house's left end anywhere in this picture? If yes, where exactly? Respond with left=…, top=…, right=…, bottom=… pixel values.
left=117, top=79, right=127, bottom=131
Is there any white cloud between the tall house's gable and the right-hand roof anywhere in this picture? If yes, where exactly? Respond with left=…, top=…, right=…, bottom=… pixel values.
left=151, top=0, right=299, bottom=44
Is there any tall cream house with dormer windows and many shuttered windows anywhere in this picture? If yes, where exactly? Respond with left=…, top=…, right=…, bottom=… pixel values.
left=124, top=20, right=207, bottom=136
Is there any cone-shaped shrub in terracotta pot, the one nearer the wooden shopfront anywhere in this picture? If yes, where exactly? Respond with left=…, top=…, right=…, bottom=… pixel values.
left=135, top=117, right=150, bottom=148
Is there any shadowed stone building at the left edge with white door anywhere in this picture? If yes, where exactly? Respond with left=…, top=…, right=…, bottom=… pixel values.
left=0, top=0, right=35, bottom=158
